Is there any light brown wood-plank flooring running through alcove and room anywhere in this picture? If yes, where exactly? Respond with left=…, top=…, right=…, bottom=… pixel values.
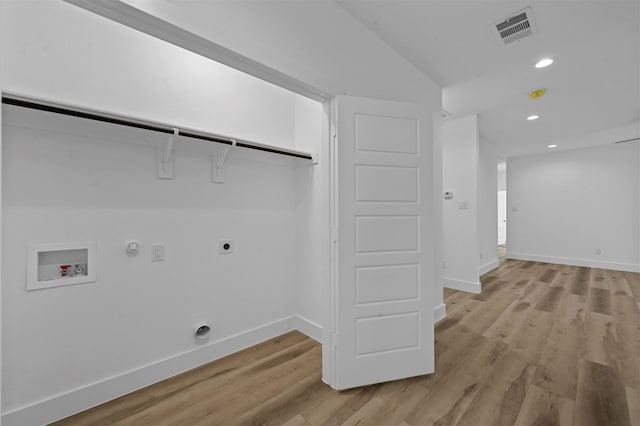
left=58, top=260, right=640, bottom=426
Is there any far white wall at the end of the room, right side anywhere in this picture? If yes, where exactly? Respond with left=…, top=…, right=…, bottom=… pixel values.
left=507, top=142, right=640, bottom=272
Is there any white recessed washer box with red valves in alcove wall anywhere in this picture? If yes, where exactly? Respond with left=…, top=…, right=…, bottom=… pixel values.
left=27, top=242, right=96, bottom=291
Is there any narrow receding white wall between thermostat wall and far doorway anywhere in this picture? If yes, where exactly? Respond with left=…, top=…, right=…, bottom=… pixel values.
left=478, top=140, right=499, bottom=275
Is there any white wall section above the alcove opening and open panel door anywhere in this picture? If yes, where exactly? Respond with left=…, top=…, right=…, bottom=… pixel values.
left=117, top=0, right=441, bottom=105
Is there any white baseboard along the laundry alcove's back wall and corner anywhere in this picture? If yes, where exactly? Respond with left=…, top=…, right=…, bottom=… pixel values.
left=2, top=315, right=302, bottom=426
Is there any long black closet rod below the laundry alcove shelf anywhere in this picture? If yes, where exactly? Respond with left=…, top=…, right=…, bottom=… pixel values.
left=2, top=94, right=313, bottom=160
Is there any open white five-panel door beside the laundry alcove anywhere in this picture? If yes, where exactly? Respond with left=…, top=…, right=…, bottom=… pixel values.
left=324, top=96, right=434, bottom=389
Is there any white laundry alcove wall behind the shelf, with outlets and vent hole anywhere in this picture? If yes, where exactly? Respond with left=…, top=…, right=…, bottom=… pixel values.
left=0, top=2, right=326, bottom=424
